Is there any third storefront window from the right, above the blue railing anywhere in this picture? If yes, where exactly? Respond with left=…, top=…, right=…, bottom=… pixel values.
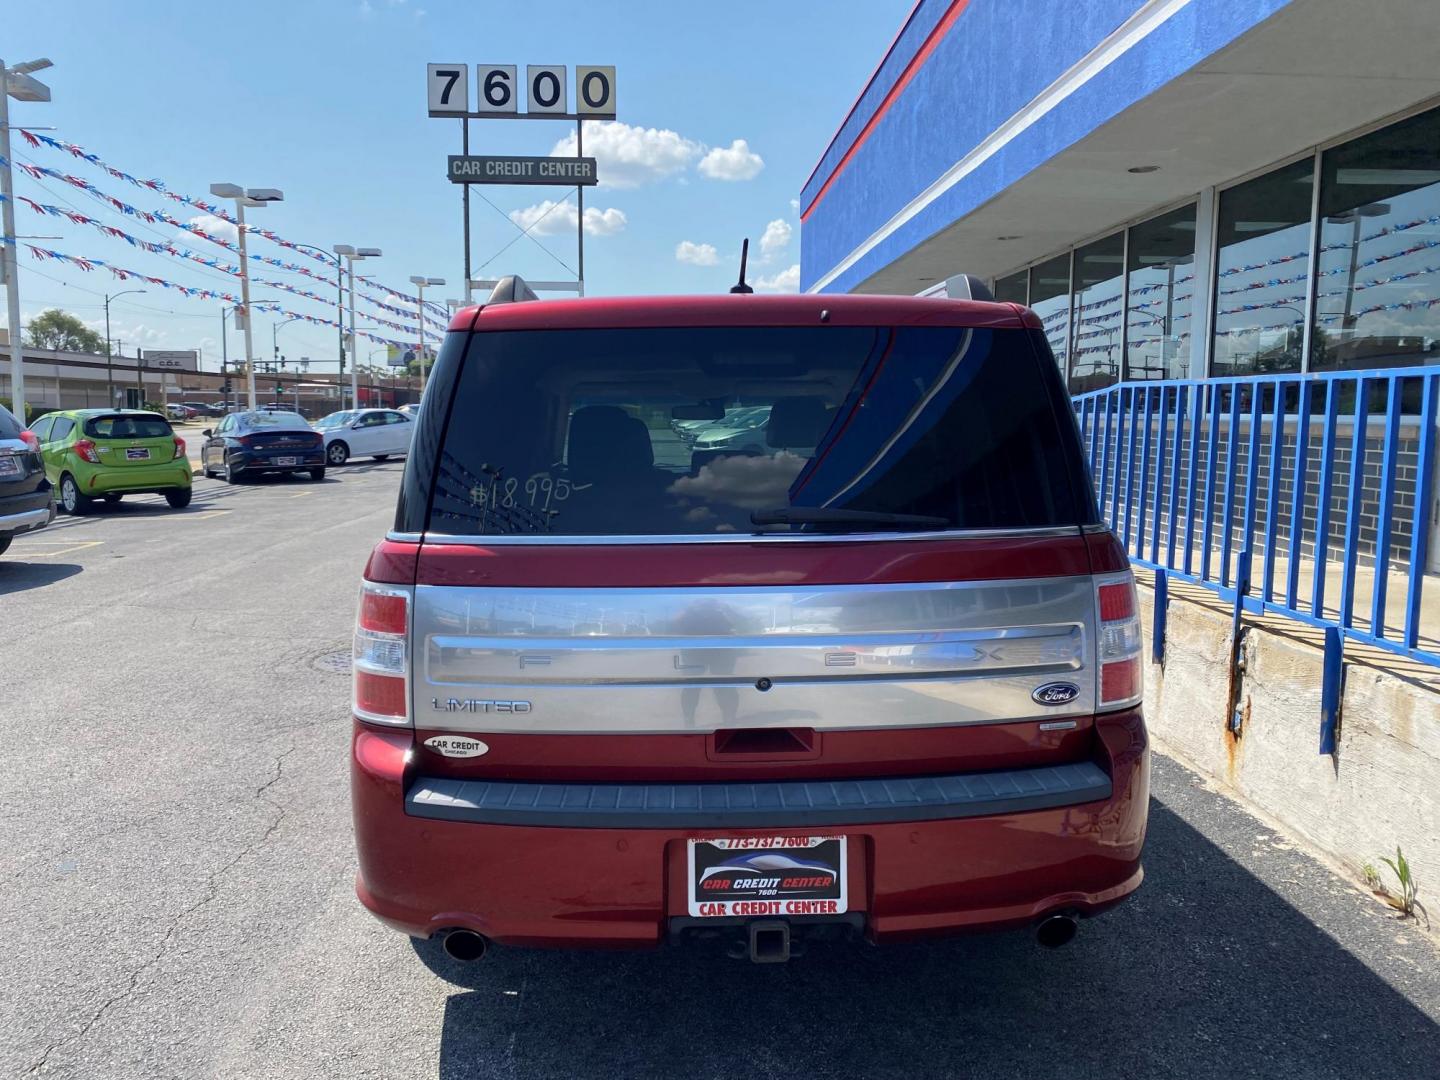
left=1125, top=206, right=1195, bottom=380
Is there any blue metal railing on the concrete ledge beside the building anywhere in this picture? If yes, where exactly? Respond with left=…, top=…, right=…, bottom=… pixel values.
left=1074, top=367, right=1440, bottom=665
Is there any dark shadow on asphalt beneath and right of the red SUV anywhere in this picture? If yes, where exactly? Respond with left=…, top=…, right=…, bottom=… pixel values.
left=416, top=804, right=1440, bottom=1080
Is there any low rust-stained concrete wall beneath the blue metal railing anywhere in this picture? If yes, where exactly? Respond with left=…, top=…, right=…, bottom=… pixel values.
left=1139, top=586, right=1440, bottom=912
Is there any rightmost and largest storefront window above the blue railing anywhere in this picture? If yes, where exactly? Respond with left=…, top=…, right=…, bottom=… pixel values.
left=1310, top=109, right=1440, bottom=370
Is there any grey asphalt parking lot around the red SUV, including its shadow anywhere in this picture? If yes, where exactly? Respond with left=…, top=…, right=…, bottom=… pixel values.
left=0, top=462, right=1440, bottom=1080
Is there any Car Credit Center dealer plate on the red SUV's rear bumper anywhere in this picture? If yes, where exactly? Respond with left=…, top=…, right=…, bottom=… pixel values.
left=687, top=837, right=848, bottom=919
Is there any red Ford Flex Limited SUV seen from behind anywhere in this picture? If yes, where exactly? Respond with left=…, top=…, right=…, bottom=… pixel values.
left=351, top=279, right=1149, bottom=960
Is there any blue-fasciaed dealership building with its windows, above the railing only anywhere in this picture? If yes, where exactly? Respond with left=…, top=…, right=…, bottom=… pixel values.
left=801, top=0, right=1440, bottom=393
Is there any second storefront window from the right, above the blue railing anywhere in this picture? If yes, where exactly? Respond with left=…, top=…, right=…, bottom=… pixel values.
left=1211, top=158, right=1315, bottom=376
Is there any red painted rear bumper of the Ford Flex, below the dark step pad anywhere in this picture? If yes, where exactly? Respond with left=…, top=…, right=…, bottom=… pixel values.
left=351, top=710, right=1149, bottom=948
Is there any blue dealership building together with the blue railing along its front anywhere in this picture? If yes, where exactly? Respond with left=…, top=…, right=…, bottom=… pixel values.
left=801, top=0, right=1440, bottom=664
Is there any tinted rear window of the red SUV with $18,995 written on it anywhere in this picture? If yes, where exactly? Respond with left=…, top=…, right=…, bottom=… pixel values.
left=414, top=327, right=1094, bottom=536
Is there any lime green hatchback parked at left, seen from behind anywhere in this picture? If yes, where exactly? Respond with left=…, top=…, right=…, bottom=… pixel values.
left=30, top=409, right=190, bottom=514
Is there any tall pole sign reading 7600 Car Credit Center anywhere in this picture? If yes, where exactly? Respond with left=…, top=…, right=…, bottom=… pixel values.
left=425, top=63, right=615, bottom=301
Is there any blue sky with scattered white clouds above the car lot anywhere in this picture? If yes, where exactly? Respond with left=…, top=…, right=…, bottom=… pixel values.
left=0, top=0, right=913, bottom=370
